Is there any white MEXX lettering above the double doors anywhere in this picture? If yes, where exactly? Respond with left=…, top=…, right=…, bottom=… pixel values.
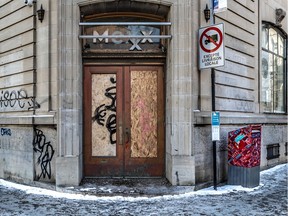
left=93, top=29, right=153, bottom=51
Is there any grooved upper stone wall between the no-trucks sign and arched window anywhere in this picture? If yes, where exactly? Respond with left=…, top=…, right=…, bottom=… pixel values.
left=200, top=1, right=258, bottom=113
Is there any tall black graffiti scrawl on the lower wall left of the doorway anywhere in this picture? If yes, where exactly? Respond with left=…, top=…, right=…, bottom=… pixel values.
left=33, top=128, right=55, bottom=180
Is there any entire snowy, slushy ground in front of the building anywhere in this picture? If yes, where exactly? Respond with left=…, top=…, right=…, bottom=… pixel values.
left=0, top=164, right=288, bottom=216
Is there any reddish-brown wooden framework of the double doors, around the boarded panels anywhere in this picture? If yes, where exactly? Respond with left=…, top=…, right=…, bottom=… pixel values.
left=83, top=64, right=166, bottom=178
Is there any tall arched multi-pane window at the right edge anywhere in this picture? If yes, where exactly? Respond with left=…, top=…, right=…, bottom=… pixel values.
left=261, top=23, right=287, bottom=113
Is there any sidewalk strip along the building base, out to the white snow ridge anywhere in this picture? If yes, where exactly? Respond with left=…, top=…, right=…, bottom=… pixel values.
left=0, top=163, right=288, bottom=198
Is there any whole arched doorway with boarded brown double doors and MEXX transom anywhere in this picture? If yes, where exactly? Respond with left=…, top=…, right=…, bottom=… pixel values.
left=81, top=1, right=169, bottom=177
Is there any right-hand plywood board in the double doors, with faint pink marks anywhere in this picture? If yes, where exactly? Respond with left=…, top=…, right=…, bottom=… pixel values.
left=131, top=71, right=157, bottom=157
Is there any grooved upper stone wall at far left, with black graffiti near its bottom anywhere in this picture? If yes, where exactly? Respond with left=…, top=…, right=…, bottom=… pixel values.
left=0, top=1, right=35, bottom=114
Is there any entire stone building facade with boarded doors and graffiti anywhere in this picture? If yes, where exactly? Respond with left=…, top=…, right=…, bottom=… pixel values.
left=0, top=0, right=288, bottom=185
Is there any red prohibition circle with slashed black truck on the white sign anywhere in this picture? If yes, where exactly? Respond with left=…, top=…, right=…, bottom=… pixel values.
left=200, top=26, right=223, bottom=53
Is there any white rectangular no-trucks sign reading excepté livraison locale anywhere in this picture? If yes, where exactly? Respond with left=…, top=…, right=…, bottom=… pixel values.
left=199, top=23, right=225, bottom=69
